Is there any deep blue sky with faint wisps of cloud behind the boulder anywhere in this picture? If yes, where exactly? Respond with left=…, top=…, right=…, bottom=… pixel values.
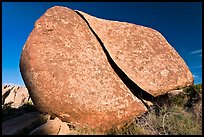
left=2, top=2, right=202, bottom=85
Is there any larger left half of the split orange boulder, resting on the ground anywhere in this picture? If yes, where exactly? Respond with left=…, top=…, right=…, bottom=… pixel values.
left=20, top=6, right=147, bottom=132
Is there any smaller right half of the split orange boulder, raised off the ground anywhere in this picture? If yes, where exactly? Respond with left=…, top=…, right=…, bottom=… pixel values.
left=75, top=11, right=194, bottom=96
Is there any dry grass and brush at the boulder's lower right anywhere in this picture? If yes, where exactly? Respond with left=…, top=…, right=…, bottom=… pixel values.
left=108, top=84, right=202, bottom=135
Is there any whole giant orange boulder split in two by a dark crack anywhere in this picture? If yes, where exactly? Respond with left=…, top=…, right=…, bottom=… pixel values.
left=20, top=6, right=193, bottom=132
